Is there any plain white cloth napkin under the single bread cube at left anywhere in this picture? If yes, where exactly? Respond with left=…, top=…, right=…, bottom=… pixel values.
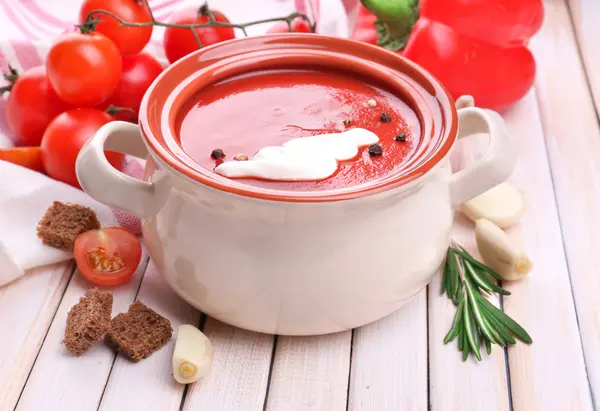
left=0, top=161, right=119, bottom=286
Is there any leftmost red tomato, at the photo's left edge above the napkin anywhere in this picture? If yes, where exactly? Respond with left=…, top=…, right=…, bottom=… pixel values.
left=6, top=66, right=68, bottom=146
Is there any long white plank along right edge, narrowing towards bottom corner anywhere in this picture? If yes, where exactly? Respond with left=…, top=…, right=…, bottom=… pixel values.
left=532, top=0, right=600, bottom=406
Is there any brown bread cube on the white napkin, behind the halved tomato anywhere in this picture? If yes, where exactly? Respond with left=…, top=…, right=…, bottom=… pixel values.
left=37, top=201, right=100, bottom=251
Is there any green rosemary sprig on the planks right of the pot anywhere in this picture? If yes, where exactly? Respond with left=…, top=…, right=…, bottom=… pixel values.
left=442, top=246, right=532, bottom=361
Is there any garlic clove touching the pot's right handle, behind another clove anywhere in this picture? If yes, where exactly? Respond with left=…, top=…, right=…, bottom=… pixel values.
left=460, top=183, right=525, bottom=228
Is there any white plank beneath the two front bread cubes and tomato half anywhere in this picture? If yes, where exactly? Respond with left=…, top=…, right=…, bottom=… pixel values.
left=16, top=251, right=148, bottom=411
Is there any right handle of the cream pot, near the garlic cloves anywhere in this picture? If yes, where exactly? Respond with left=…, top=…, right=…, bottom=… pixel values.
left=450, top=97, right=517, bottom=205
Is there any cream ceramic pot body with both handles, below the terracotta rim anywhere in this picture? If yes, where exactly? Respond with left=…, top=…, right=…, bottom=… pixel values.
left=77, top=35, right=515, bottom=335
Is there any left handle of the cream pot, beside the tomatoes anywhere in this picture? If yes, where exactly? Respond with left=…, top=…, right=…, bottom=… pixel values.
left=75, top=121, right=155, bottom=218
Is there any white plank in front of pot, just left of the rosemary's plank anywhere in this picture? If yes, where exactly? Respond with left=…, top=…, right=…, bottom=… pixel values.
left=346, top=290, right=428, bottom=411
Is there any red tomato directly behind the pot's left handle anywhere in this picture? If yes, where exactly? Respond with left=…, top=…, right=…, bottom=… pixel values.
left=41, top=108, right=125, bottom=188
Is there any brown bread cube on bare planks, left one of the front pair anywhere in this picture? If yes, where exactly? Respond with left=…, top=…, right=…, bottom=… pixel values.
left=63, top=288, right=113, bottom=356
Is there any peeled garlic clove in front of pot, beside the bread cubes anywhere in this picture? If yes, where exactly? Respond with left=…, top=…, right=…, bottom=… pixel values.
left=173, top=324, right=213, bottom=384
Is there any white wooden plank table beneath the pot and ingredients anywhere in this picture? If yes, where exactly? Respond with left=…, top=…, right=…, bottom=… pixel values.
left=0, top=0, right=600, bottom=411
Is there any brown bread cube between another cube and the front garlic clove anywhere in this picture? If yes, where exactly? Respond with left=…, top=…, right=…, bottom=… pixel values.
left=104, top=300, right=173, bottom=362
